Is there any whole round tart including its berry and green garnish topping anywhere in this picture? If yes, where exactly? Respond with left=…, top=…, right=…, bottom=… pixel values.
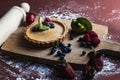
left=25, top=17, right=68, bottom=47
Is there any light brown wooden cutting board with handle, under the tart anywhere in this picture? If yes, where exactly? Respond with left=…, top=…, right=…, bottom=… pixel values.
left=1, top=17, right=120, bottom=65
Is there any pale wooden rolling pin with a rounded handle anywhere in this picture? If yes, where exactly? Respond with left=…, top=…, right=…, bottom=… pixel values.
left=0, top=3, right=30, bottom=46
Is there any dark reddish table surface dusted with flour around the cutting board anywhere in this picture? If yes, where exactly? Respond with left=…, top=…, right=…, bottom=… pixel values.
left=0, top=0, right=120, bottom=80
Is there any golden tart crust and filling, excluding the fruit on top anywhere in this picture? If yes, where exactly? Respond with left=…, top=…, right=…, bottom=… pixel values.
left=24, top=16, right=68, bottom=47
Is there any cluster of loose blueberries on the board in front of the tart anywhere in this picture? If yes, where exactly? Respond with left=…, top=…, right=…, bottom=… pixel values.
left=50, top=42, right=72, bottom=60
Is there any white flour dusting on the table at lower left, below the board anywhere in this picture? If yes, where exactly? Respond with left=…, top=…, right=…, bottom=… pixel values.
left=1, top=57, right=53, bottom=80
